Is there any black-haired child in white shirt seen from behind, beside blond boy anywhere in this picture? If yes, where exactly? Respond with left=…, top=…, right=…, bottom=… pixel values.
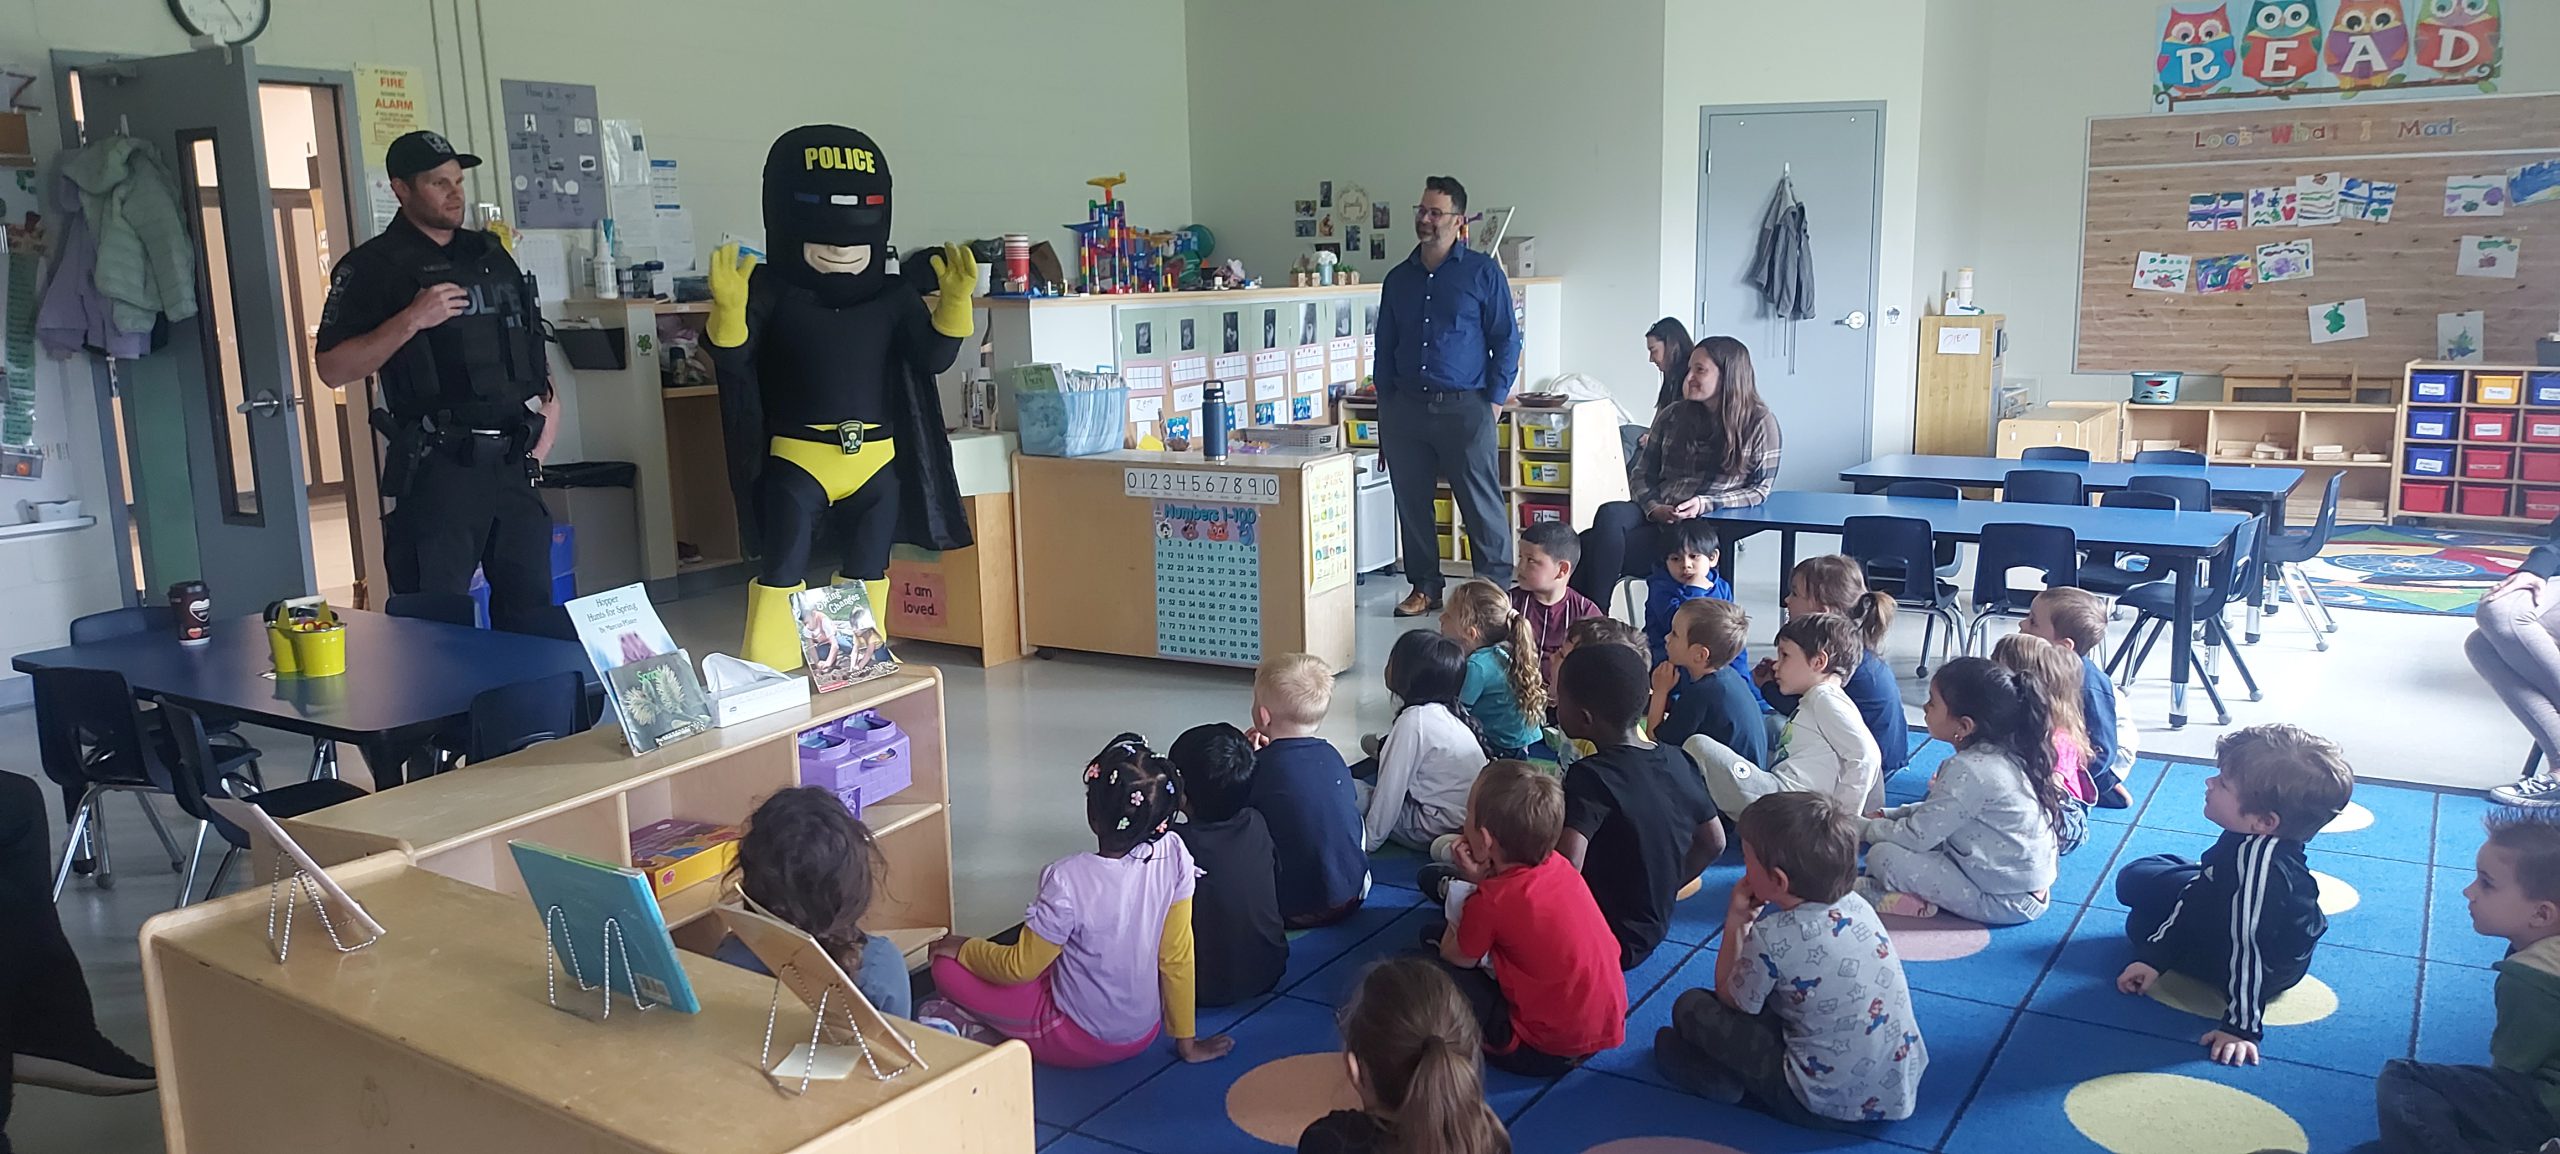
left=1352, top=629, right=1490, bottom=852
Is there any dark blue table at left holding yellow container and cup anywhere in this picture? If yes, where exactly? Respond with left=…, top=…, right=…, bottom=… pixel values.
left=10, top=609, right=599, bottom=788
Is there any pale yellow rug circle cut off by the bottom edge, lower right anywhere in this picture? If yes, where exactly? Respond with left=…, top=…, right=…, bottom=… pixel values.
left=2063, top=1072, right=2312, bottom=1154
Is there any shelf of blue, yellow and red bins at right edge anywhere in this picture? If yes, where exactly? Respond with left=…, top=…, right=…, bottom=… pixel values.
left=2391, top=361, right=2560, bottom=525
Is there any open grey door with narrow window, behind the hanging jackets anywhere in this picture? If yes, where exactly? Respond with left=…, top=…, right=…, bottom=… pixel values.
left=69, top=46, right=312, bottom=612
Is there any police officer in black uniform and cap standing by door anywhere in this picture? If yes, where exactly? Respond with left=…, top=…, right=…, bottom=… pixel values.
left=317, top=133, right=558, bottom=632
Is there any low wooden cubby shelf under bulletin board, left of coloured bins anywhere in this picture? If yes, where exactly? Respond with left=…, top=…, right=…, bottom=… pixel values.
left=2117, top=402, right=2401, bottom=525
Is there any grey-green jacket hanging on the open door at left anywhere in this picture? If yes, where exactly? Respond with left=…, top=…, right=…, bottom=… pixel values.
left=61, top=136, right=195, bottom=333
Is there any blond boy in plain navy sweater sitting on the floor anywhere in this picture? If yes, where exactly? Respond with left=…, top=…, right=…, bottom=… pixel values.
left=1244, top=652, right=1370, bottom=929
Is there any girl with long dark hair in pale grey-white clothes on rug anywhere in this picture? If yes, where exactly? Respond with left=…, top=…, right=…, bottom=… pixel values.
left=1859, top=658, right=2063, bottom=926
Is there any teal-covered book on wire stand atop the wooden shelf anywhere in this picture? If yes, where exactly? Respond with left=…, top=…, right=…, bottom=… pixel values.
left=507, top=842, right=701, bottom=1013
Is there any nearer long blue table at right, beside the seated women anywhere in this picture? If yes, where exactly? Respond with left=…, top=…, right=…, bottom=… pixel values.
left=1705, top=489, right=2248, bottom=729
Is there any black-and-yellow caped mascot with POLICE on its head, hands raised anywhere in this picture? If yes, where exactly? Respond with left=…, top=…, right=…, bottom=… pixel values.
left=704, top=125, right=978, bottom=670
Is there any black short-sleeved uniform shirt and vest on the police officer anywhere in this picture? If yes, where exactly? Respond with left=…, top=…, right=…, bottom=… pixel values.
left=317, top=215, right=550, bottom=430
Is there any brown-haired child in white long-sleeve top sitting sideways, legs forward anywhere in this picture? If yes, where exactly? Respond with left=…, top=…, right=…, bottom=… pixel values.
left=1682, top=614, right=1884, bottom=816
